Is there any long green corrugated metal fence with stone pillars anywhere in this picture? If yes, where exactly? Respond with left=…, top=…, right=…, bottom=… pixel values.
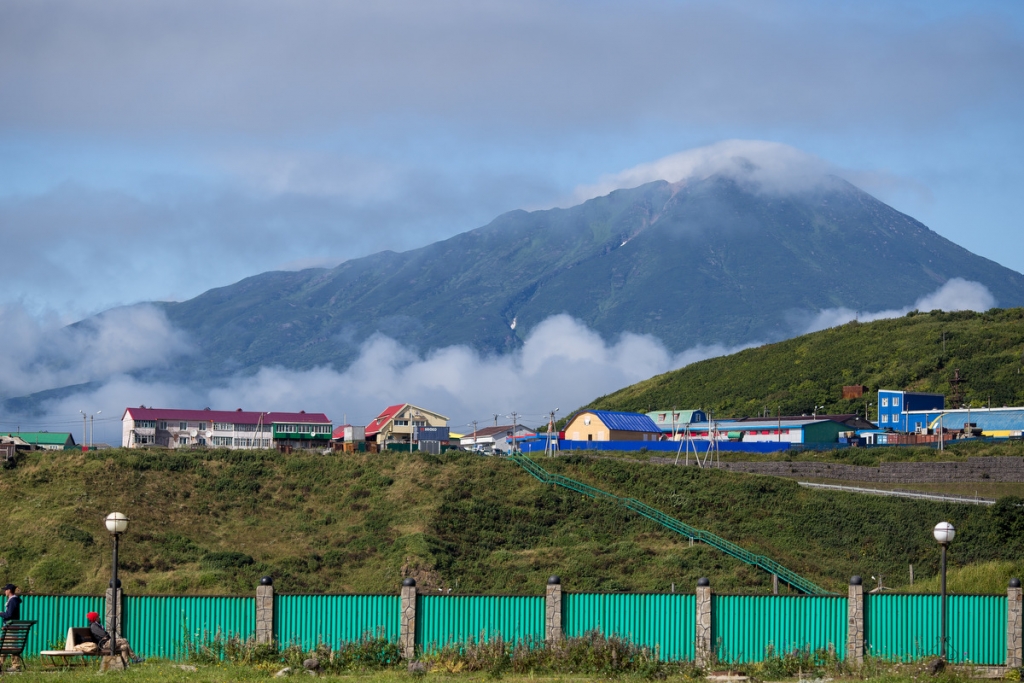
left=22, top=586, right=1024, bottom=666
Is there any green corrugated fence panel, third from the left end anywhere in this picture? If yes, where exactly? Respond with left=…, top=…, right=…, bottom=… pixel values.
left=273, top=595, right=401, bottom=650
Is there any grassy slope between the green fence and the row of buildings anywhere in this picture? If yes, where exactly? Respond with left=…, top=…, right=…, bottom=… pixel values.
left=0, top=451, right=1024, bottom=594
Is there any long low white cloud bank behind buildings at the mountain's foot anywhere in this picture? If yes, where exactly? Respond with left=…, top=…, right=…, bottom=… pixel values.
left=4, top=315, right=740, bottom=442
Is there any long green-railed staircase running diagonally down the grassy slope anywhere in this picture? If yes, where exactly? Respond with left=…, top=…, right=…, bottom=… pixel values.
left=509, top=453, right=833, bottom=595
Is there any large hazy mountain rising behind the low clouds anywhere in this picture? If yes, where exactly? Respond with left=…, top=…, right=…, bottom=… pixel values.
left=149, top=177, right=1024, bottom=378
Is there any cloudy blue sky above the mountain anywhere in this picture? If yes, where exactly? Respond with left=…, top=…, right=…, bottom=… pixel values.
left=0, top=0, right=1024, bottom=322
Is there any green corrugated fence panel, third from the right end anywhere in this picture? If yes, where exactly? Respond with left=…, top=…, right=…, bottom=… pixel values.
left=562, top=593, right=697, bottom=659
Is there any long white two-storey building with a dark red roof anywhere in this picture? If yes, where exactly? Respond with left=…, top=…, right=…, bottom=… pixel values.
left=121, top=405, right=331, bottom=449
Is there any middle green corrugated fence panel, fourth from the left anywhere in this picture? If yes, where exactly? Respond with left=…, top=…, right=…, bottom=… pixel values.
left=416, top=595, right=545, bottom=651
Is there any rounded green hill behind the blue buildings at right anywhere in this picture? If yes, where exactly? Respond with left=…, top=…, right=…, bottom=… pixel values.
left=589, top=308, right=1024, bottom=417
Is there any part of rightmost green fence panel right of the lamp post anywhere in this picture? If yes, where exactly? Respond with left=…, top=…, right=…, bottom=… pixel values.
left=946, top=595, right=1007, bottom=666
